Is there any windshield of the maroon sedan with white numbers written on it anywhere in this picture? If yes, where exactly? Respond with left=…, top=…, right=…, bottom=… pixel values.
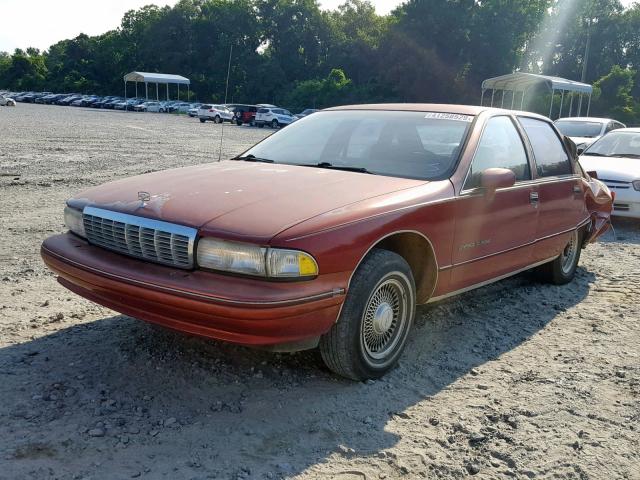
left=238, top=110, right=473, bottom=180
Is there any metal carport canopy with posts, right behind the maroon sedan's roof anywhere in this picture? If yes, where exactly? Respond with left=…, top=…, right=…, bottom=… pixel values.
left=480, top=72, right=593, bottom=118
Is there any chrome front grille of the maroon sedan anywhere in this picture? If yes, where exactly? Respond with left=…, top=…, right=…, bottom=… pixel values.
left=82, top=207, right=197, bottom=268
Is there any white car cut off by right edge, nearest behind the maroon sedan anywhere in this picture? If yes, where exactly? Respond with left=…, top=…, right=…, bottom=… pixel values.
left=580, top=128, right=640, bottom=218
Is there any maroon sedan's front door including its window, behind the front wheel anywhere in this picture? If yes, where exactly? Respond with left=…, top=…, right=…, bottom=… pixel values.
left=451, top=115, right=538, bottom=291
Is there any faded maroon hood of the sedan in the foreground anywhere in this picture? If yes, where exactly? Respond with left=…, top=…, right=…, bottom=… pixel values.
left=68, top=161, right=426, bottom=242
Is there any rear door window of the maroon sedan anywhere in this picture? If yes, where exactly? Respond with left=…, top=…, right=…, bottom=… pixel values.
left=519, top=117, right=573, bottom=177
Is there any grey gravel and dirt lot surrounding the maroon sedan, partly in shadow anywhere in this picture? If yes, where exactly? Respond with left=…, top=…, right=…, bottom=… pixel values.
left=0, top=104, right=640, bottom=480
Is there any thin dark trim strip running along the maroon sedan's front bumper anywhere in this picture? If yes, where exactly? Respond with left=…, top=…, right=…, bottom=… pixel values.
left=41, top=247, right=345, bottom=307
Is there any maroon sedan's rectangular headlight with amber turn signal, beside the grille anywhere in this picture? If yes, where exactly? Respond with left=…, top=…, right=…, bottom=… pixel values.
left=197, top=238, right=318, bottom=278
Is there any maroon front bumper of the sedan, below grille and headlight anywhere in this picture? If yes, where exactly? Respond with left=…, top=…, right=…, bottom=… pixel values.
left=41, top=233, right=348, bottom=346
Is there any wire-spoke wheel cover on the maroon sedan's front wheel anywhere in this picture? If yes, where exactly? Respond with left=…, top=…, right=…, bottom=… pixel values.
left=360, top=272, right=410, bottom=364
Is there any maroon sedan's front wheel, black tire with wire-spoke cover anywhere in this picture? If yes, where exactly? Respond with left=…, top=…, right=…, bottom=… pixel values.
left=320, top=249, right=416, bottom=381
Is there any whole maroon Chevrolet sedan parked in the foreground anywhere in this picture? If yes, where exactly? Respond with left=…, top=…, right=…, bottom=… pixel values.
left=42, top=104, right=612, bottom=379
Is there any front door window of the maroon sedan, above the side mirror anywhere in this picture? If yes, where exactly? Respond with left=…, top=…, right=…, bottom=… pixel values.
left=464, top=117, right=531, bottom=189
